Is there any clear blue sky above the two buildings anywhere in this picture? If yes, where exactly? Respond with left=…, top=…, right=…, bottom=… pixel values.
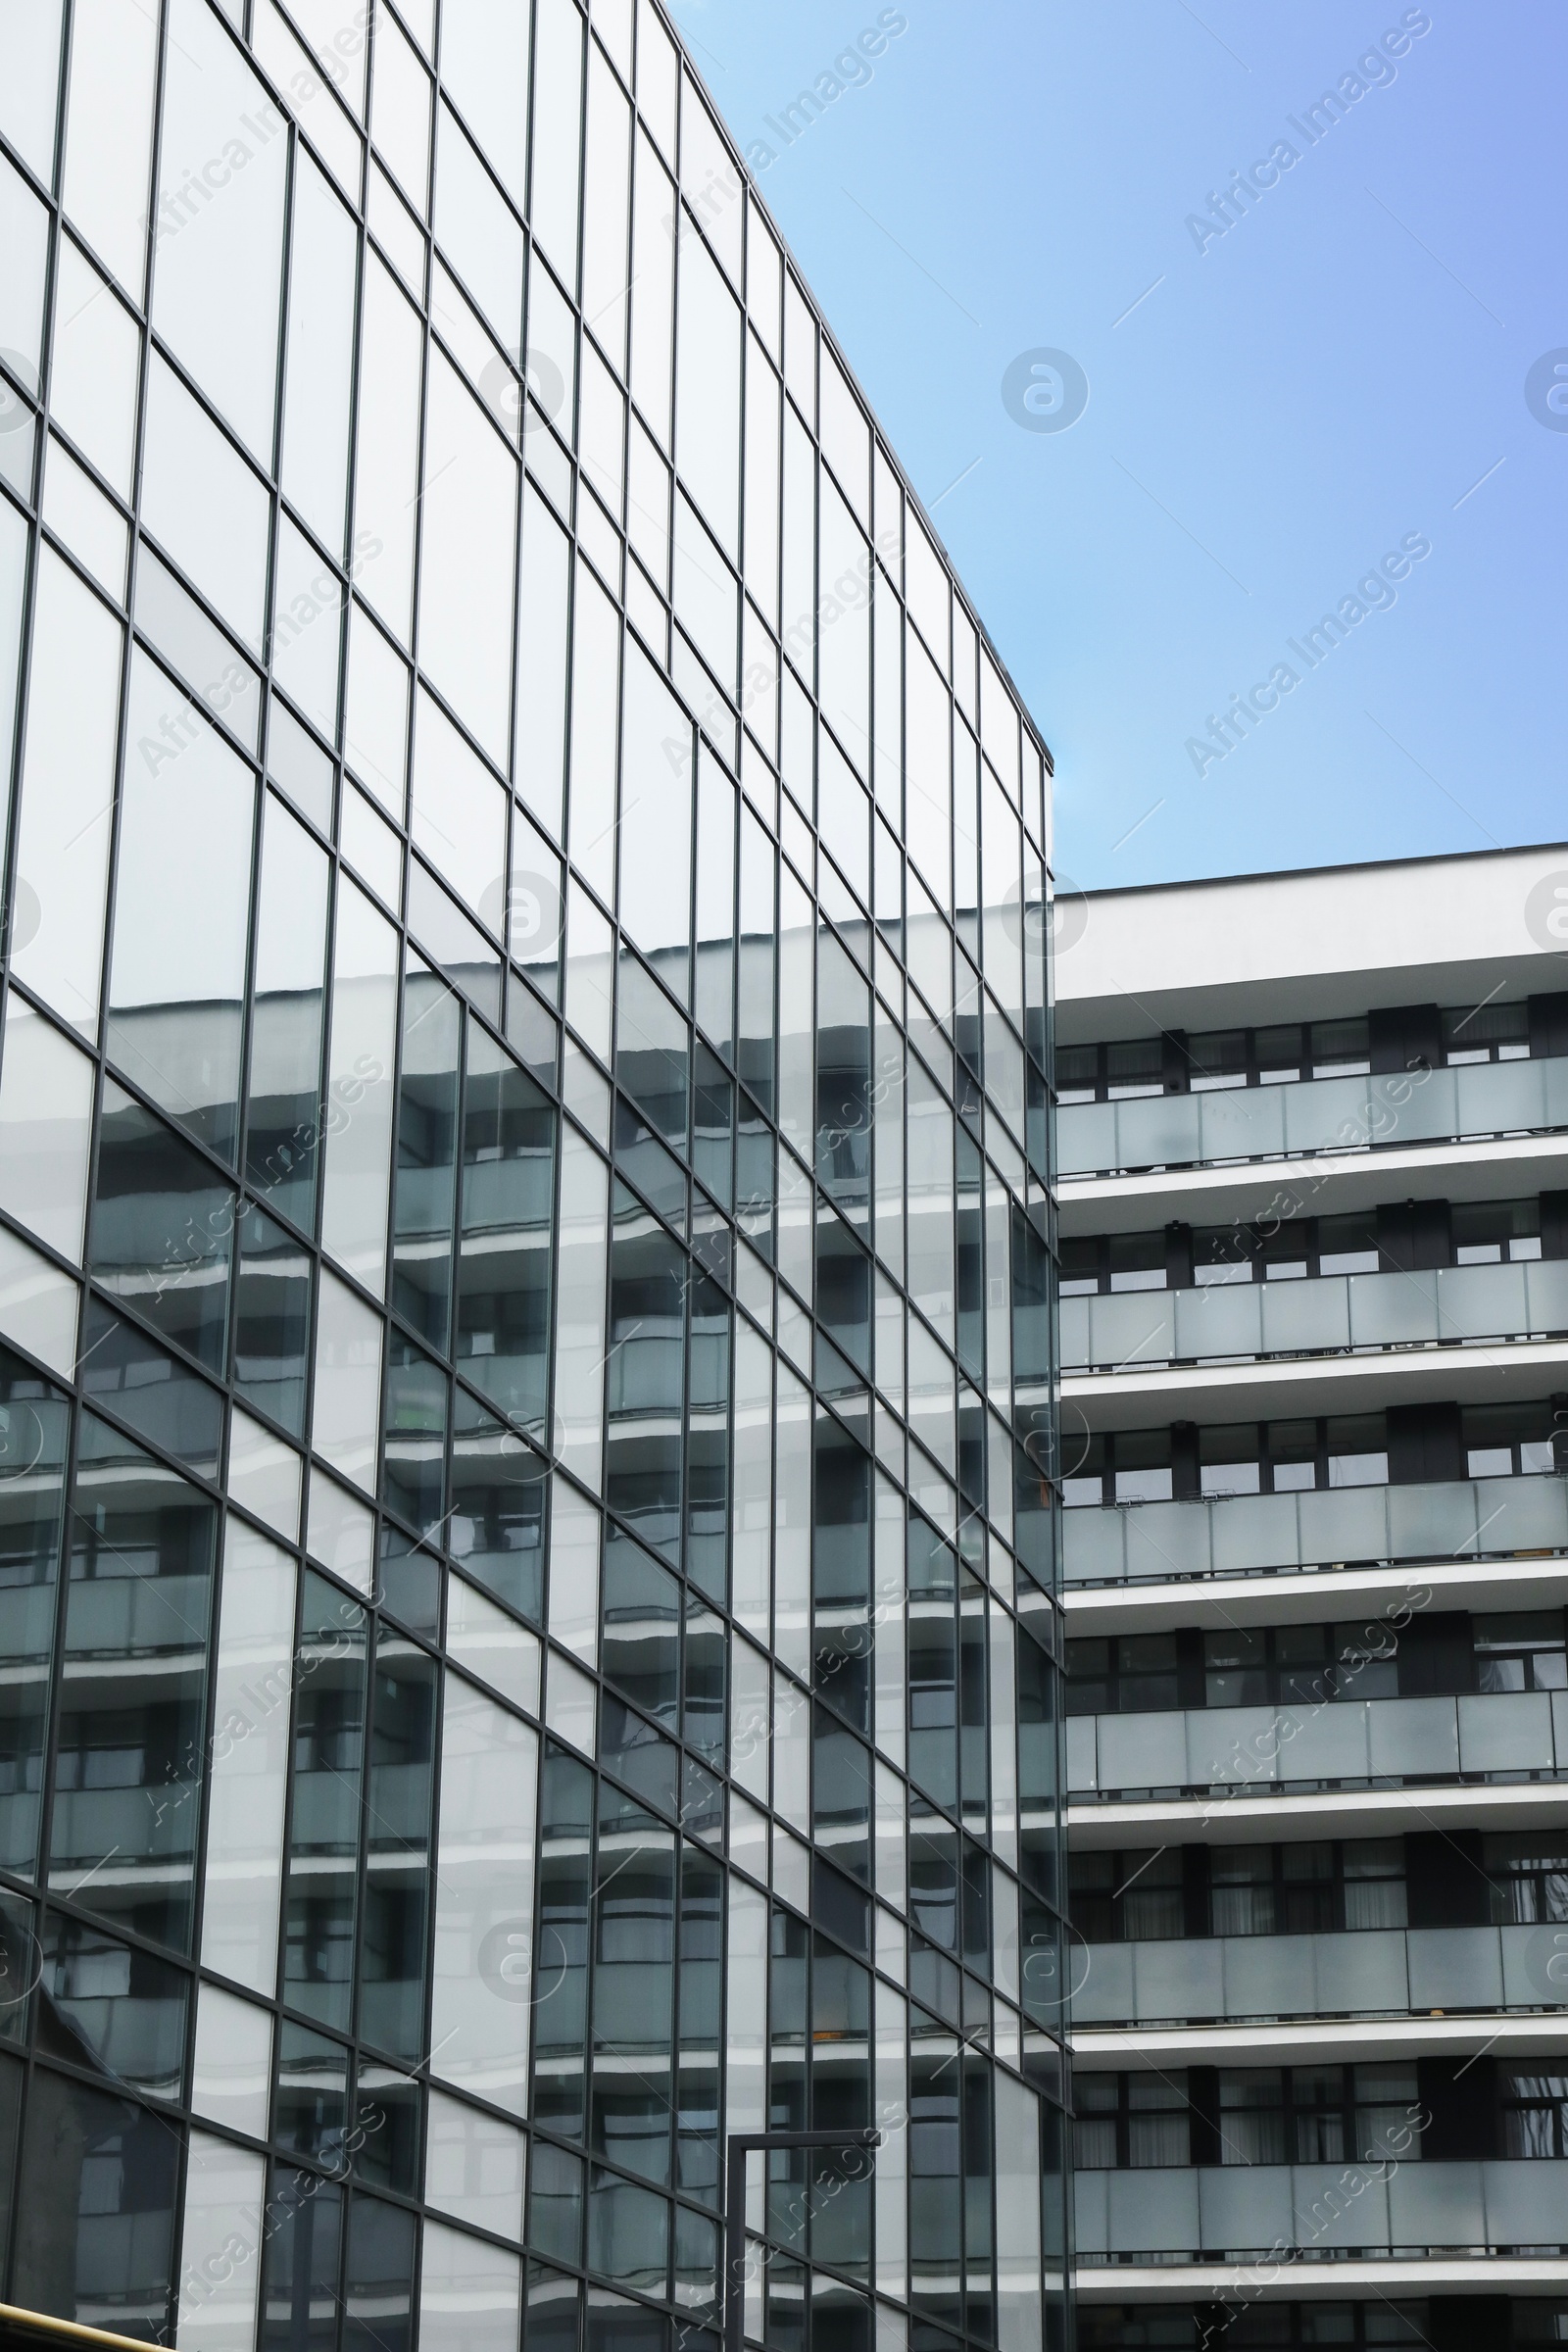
left=674, top=0, right=1568, bottom=887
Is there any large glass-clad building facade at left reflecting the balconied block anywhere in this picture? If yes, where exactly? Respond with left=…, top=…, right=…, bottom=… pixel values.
left=0, top=0, right=1067, bottom=2352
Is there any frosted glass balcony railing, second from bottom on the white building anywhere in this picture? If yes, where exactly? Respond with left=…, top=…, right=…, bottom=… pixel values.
left=1072, top=1922, right=1568, bottom=2032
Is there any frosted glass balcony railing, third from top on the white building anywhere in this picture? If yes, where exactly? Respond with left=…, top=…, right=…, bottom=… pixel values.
left=1062, top=1477, right=1568, bottom=1586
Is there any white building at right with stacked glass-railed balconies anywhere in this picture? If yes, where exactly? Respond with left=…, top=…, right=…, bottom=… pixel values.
left=1055, top=845, right=1568, bottom=2352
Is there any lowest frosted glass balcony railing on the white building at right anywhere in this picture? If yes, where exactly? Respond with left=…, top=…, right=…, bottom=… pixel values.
left=1077, top=2154, right=1568, bottom=2263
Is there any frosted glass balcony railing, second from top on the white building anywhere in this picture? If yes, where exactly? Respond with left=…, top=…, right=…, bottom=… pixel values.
left=1062, top=1258, right=1568, bottom=1371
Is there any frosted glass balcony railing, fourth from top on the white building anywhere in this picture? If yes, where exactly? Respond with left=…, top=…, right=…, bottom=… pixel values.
left=1067, top=1691, right=1568, bottom=1788
